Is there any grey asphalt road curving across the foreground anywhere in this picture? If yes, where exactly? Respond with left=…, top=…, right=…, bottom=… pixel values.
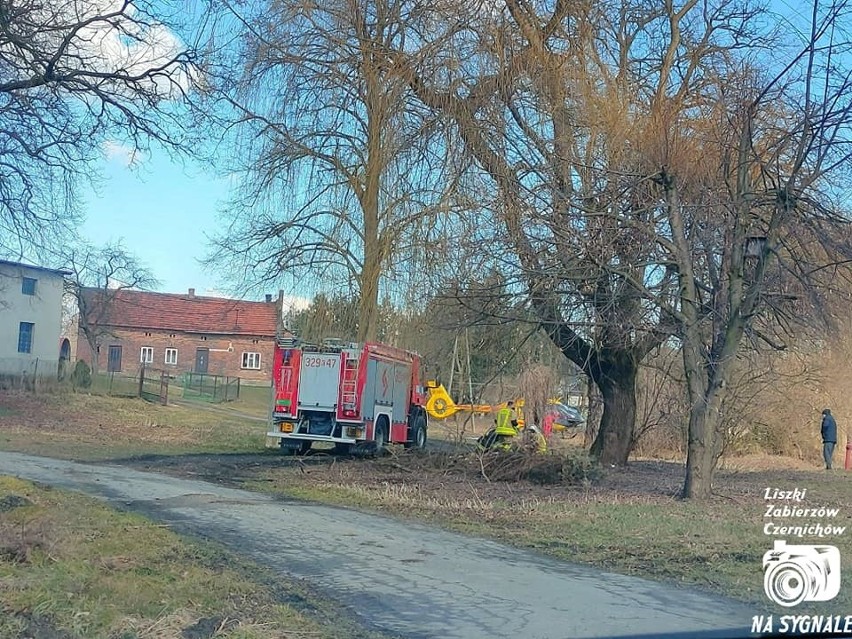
left=0, top=452, right=759, bottom=639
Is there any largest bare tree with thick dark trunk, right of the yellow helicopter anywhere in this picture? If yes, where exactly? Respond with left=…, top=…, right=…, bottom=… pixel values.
left=393, top=0, right=763, bottom=464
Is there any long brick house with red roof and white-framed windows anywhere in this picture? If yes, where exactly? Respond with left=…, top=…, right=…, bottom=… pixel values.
left=77, top=288, right=283, bottom=383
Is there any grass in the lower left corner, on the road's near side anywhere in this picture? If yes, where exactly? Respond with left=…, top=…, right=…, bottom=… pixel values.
left=0, top=477, right=382, bottom=639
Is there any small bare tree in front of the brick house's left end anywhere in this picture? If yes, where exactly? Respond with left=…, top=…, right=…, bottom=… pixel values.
left=65, top=243, right=158, bottom=374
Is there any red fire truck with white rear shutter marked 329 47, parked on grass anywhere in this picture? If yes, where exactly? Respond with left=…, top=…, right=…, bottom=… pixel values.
left=267, top=338, right=426, bottom=454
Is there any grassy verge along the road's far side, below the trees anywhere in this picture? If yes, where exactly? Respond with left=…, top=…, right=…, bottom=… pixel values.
left=253, top=456, right=852, bottom=614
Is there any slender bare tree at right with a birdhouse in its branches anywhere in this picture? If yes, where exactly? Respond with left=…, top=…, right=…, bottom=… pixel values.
left=658, top=2, right=852, bottom=498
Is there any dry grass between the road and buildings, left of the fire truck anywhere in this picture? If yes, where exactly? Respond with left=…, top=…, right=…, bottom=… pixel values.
left=0, top=392, right=264, bottom=459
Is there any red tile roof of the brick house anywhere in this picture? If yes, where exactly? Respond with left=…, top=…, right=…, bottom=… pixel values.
left=83, top=288, right=278, bottom=337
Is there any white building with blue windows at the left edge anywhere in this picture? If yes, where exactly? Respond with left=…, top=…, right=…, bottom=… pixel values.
left=0, top=260, right=70, bottom=376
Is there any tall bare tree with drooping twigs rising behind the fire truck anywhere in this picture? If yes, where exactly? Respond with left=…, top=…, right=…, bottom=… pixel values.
left=206, top=0, right=456, bottom=340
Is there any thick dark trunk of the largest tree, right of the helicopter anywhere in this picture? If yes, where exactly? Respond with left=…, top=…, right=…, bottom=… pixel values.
left=591, top=355, right=639, bottom=466
